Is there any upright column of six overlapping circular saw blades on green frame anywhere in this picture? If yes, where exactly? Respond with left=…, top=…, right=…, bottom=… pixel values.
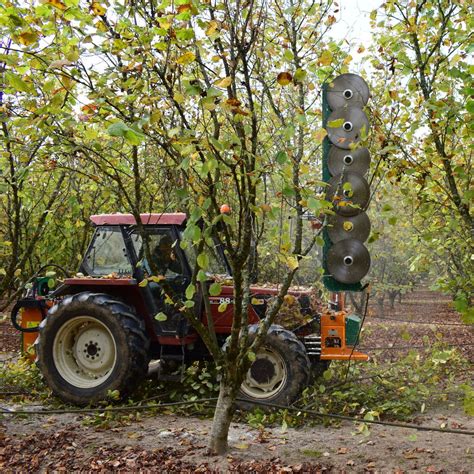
left=323, top=74, right=370, bottom=291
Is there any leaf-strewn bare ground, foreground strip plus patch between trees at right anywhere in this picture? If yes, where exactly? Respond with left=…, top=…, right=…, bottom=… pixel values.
left=0, top=290, right=474, bottom=473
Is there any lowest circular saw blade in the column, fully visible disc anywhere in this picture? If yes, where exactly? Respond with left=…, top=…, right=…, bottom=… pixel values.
left=327, top=239, right=370, bottom=284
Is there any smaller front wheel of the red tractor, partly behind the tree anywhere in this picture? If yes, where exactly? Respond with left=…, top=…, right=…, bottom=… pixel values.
left=238, top=325, right=310, bottom=410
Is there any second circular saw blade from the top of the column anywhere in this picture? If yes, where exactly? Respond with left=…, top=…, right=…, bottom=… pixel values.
left=326, top=107, right=370, bottom=150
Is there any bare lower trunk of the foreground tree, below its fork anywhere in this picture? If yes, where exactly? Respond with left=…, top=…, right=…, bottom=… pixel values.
left=209, top=378, right=236, bottom=454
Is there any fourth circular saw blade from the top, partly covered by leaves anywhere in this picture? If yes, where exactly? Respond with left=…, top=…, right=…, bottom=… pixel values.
left=326, top=171, right=370, bottom=216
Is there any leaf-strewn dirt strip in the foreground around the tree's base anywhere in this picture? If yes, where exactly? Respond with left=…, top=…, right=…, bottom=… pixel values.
left=0, top=411, right=474, bottom=473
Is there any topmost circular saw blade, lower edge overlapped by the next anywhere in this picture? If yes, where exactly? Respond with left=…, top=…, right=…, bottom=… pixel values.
left=327, top=73, right=370, bottom=110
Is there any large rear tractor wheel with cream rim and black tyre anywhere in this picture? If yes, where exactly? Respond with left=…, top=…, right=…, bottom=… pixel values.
left=35, top=292, right=149, bottom=405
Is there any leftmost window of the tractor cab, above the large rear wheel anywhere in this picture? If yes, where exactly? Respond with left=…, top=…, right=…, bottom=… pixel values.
left=82, top=226, right=132, bottom=276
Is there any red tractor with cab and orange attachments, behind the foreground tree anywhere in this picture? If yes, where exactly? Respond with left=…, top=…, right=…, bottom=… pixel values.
left=12, top=213, right=367, bottom=405
